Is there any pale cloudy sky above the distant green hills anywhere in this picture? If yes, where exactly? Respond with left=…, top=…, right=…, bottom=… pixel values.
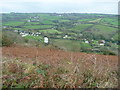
left=0, top=0, right=119, bottom=14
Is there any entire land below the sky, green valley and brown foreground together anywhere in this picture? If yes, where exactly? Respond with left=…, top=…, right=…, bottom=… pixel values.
left=0, top=12, right=120, bottom=88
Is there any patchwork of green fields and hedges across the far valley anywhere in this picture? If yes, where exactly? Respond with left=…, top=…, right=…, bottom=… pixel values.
left=3, top=13, right=120, bottom=52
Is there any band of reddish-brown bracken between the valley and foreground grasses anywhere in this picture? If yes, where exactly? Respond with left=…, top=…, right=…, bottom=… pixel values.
left=2, top=46, right=118, bottom=69
